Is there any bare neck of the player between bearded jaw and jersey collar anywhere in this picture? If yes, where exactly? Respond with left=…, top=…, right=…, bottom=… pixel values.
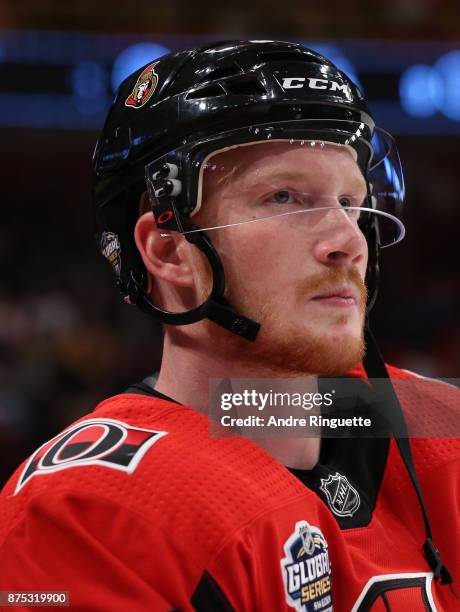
left=155, top=334, right=321, bottom=470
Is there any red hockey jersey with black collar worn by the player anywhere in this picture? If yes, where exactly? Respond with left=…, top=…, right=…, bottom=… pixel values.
left=0, top=369, right=460, bottom=612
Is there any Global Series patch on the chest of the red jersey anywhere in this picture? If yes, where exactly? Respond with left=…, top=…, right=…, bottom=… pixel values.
left=281, top=521, right=333, bottom=612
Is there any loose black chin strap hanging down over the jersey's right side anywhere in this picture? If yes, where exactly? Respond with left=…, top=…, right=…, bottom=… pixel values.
left=363, top=321, right=452, bottom=584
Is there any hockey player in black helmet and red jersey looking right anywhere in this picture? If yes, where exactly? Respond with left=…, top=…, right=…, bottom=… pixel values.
left=0, top=41, right=460, bottom=612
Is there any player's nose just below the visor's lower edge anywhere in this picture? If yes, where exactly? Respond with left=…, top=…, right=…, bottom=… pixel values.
left=313, top=205, right=367, bottom=266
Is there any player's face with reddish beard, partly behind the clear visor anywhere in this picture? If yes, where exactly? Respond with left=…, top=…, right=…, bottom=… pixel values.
left=193, top=142, right=367, bottom=375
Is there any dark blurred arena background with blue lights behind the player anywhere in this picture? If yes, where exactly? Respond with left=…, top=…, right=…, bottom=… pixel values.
left=0, top=0, right=460, bottom=484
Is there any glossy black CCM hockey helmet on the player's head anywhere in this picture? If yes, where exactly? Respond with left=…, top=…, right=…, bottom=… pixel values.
left=93, top=41, right=404, bottom=339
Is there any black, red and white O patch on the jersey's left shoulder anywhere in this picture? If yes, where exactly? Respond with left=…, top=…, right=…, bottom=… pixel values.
left=14, top=419, right=167, bottom=495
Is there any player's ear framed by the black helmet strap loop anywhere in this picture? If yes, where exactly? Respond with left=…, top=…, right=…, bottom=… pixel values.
left=134, top=211, right=194, bottom=287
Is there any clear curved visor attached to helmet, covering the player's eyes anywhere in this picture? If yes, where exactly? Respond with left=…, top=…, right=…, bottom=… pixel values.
left=146, top=124, right=405, bottom=248
